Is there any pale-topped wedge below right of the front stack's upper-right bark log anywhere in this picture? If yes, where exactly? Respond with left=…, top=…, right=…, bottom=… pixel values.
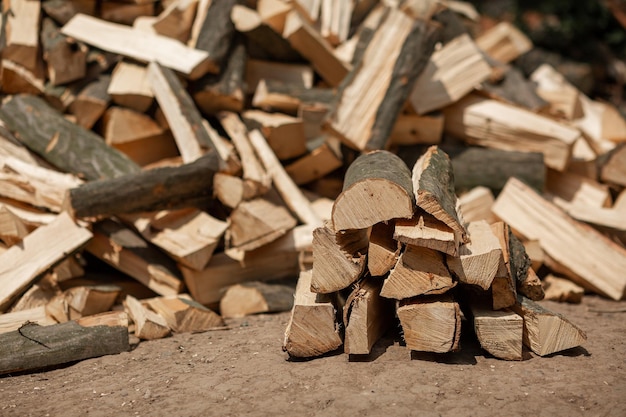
left=448, top=220, right=503, bottom=290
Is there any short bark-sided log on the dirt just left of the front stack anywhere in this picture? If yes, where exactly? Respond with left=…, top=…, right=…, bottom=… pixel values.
left=220, top=281, right=294, bottom=317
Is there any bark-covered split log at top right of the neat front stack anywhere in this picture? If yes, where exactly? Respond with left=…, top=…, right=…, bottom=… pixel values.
left=412, top=146, right=468, bottom=242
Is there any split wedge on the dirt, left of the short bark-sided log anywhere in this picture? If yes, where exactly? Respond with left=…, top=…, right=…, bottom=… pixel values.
left=148, top=297, right=224, bottom=333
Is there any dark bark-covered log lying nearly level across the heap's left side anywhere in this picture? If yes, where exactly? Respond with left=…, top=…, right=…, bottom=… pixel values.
left=65, top=152, right=219, bottom=218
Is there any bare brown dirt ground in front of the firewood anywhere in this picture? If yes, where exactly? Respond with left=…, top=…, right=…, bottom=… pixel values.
left=0, top=296, right=626, bottom=417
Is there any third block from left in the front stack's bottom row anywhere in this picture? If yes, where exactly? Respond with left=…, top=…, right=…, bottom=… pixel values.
left=397, top=295, right=461, bottom=353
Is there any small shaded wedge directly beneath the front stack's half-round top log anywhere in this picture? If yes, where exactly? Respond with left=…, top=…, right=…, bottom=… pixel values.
left=367, top=222, right=402, bottom=277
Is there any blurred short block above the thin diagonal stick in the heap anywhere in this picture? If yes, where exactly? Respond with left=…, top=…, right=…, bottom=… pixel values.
left=241, top=110, right=306, bottom=160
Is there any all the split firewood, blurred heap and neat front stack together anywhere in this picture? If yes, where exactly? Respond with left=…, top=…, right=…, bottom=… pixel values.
left=0, top=0, right=626, bottom=373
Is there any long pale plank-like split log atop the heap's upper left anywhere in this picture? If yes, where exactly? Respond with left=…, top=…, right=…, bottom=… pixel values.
left=61, top=14, right=212, bottom=80
